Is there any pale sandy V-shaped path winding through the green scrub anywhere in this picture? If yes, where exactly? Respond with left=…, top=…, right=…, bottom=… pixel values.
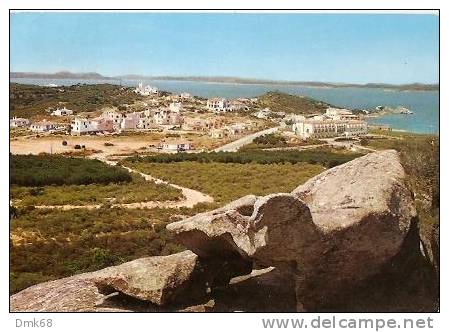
left=30, top=157, right=214, bottom=210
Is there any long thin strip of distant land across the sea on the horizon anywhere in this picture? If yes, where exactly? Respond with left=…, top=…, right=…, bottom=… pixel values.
left=10, top=71, right=440, bottom=91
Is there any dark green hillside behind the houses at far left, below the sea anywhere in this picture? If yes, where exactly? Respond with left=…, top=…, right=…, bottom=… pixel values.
left=9, top=83, right=142, bottom=118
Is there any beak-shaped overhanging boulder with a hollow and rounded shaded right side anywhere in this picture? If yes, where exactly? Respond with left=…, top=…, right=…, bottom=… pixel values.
left=167, top=194, right=320, bottom=266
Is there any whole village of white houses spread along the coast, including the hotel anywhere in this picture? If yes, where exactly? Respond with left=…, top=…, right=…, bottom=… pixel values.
left=10, top=83, right=368, bottom=153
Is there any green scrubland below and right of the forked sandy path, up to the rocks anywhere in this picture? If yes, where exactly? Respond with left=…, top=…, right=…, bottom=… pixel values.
left=10, top=162, right=324, bottom=293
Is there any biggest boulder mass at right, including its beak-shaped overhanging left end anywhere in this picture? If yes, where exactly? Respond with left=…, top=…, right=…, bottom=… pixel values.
left=167, top=150, right=416, bottom=310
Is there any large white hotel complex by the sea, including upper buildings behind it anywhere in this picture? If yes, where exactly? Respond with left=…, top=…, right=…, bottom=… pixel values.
left=292, top=108, right=368, bottom=139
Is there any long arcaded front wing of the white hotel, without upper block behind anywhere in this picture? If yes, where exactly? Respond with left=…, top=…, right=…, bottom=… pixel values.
left=293, top=119, right=368, bottom=139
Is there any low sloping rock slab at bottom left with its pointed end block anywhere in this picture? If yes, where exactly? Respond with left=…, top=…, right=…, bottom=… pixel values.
left=11, top=250, right=251, bottom=311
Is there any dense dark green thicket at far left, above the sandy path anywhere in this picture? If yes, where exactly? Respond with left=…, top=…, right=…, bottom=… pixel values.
left=10, top=155, right=132, bottom=187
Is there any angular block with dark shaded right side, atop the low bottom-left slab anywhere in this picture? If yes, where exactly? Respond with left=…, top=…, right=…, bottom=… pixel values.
left=95, top=250, right=251, bottom=305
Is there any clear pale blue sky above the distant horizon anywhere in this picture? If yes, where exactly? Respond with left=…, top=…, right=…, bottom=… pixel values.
left=11, top=12, right=439, bottom=83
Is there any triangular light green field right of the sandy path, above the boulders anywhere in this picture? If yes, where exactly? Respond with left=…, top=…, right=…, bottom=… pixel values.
left=122, top=161, right=324, bottom=206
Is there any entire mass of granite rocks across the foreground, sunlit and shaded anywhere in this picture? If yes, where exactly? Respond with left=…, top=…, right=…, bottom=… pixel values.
left=11, top=150, right=434, bottom=311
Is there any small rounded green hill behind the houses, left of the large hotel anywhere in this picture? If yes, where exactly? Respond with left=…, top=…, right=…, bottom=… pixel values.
left=257, top=91, right=331, bottom=114
